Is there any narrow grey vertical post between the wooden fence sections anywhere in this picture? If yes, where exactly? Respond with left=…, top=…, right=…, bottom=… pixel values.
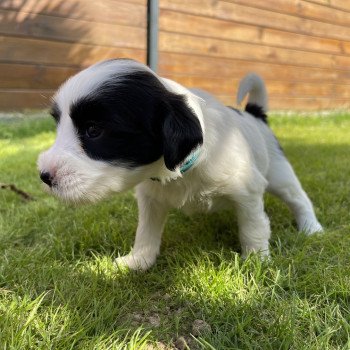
left=147, top=0, right=159, bottom=72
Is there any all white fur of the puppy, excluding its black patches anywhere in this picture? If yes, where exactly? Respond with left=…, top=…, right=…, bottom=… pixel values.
left=38, top=61, right=322, bottom=270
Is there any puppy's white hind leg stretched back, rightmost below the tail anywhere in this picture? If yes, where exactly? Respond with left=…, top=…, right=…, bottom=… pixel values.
left=267, top=153, right=323, bottom=234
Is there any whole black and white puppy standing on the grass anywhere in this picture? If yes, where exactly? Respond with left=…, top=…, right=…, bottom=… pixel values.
left=38, top=59, right=322, bottom=269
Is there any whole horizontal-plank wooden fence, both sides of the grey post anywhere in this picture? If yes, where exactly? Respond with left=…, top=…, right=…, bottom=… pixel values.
left=0, top=0, right=350, bottom=110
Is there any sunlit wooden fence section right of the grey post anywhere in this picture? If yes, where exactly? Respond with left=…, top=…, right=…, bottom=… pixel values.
left=159, top=0, right=350, bottom=110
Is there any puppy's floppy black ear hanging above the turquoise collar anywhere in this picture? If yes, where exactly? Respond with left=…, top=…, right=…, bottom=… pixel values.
left=163, top=96, right=203, bottom=170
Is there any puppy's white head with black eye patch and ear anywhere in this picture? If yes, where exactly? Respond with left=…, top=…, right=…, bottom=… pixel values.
left=38, top=59, right=203, bottom=201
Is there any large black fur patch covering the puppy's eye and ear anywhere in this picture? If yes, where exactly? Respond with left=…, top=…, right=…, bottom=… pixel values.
left=70, top=71, right=203, bottom=170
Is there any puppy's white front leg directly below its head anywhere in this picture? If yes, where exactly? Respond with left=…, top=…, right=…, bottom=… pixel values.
left=116, top=191, right=168, bottom=270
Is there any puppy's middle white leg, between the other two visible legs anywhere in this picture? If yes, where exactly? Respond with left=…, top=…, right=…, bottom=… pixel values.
left=236, top=194, right=270, bottom=257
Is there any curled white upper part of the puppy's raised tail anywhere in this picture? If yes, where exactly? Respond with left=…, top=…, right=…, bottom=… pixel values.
left=237, top=73, right=268, bottom=114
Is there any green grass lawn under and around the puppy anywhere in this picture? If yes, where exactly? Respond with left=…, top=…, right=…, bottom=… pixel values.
left=0, top=114, right=350, bottom=350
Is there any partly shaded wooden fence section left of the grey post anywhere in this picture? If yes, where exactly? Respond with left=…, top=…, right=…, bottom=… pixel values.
left=0, top=0, right=147, bottom=109
